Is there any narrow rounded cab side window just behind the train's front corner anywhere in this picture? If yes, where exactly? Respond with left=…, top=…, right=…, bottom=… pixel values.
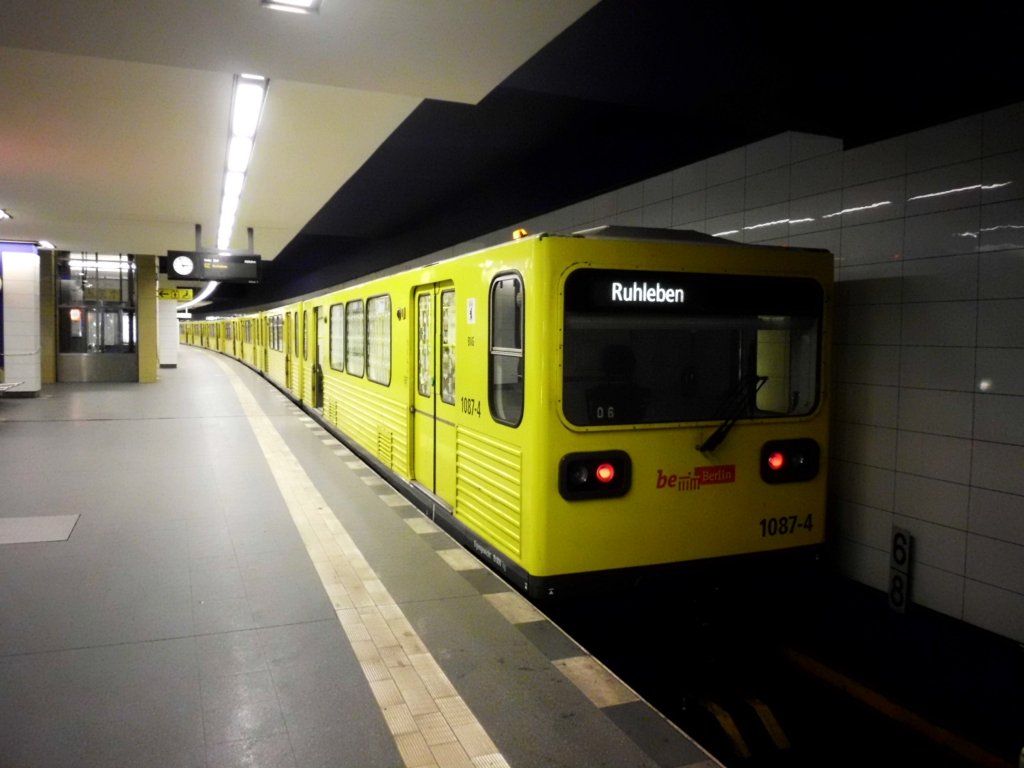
left=488, top=274, right=525, bottom=427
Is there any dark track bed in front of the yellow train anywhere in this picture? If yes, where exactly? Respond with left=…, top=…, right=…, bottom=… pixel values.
left=548, top=583, right=1016, bottom=768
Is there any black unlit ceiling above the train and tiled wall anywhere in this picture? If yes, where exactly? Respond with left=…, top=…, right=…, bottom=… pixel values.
left=208, top=0, right=1024, bottom=311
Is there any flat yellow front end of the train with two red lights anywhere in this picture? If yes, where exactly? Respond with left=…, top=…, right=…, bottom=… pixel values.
left=528, top=233, right=833, bottom=596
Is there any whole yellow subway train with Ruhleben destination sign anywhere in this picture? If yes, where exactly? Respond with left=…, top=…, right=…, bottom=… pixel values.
left=180, top=227, right=834, bottom=598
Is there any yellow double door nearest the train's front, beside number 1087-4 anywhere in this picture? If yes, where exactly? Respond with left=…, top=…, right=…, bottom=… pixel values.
left=413, top=283, right=456, bottom=507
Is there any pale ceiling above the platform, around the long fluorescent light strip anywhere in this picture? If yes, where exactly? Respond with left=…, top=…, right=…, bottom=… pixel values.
left=0, top=0, right=596, bottom=258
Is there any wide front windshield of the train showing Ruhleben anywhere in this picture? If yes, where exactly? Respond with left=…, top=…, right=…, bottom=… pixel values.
left=562, top=269, right=823, bottom=426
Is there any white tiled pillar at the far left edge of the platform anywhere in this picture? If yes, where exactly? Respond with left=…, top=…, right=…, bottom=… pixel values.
left=0, top=246, right=42, bottom=393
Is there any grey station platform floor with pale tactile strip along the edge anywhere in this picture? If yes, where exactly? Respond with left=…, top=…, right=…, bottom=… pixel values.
left=0, top=348, right=719, bottom=768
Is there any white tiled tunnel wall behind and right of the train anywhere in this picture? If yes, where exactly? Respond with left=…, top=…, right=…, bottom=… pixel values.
left=437, top=103, right=1024, bottom=641
